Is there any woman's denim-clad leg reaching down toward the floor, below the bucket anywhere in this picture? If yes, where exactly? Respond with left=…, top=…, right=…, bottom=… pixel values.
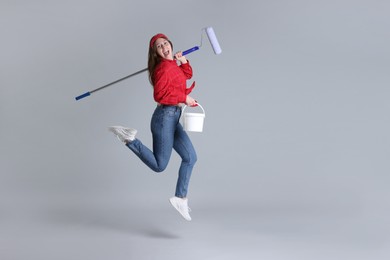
left=173, top=124, right=197, bottom=198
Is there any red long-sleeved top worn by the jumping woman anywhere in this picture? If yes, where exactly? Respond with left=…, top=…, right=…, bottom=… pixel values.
left=153, top=59, right=195, bottom=105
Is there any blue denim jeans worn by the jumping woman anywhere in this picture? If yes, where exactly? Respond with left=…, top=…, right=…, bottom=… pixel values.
left=126, top=105, right=197, bottom=198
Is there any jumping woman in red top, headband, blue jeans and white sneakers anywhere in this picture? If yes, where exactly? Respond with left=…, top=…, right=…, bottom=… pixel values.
left=109, top=33, right=197, bottom=221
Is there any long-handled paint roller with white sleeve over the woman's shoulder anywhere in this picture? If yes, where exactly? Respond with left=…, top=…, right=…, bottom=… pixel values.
left=75, top=27, right=222, bottom=100
